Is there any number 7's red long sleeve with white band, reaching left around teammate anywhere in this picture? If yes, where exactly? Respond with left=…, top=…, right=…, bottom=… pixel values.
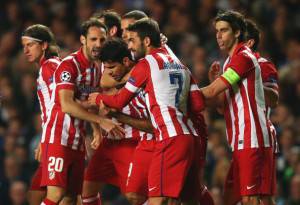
left=96, top=60, right=150, bottom=110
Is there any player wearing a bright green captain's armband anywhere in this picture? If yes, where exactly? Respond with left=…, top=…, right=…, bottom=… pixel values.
left=202, top=11, right=275, bottom=204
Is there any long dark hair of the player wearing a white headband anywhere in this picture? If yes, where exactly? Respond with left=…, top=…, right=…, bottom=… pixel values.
left=22, top=24, right=59, bottom=59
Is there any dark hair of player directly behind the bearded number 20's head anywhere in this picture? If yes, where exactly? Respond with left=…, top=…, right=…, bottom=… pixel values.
left=93, top=10, right=122, bottom=37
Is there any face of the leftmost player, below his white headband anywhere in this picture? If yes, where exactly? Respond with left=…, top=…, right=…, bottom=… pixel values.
left=22, top=38, right=44, bottom=63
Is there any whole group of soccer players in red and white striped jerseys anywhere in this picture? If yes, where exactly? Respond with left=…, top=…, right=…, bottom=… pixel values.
left=22, top=7, right=278, bottom=205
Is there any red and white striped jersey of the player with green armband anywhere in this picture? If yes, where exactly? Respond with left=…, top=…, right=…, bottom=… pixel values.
left=221, top=43, right=272, bottom=150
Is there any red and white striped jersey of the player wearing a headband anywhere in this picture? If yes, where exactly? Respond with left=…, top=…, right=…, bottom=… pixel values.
left=36, top=57, right=60, bottom=127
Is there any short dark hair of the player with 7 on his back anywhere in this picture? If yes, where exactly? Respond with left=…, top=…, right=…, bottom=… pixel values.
left=127, top=18, right=161, bottom=47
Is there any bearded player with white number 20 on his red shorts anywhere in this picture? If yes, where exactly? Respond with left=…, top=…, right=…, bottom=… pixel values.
left=41, top=20, right=124, bottom=205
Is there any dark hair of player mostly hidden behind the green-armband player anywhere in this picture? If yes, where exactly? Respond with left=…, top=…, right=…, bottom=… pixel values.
left=245, top=19, right=260, bottom=51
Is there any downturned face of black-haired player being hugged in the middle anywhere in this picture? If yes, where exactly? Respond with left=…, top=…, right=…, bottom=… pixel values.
left=104, top=61, right=127, bottom=81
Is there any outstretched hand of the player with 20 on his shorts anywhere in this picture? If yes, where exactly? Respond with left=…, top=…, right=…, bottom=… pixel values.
left=99, top=118, right=125, bottom=138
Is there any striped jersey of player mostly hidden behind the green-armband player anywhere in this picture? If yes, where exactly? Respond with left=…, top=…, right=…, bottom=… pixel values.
left=255, top=53, right=279, bottom=153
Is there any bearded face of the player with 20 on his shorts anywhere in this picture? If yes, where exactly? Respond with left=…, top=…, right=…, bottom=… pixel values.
left=81, top=26, right=106, bottom=61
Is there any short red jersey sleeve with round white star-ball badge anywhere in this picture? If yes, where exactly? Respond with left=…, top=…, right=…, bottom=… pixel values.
left=54, top=61, right=78, bottom=90
